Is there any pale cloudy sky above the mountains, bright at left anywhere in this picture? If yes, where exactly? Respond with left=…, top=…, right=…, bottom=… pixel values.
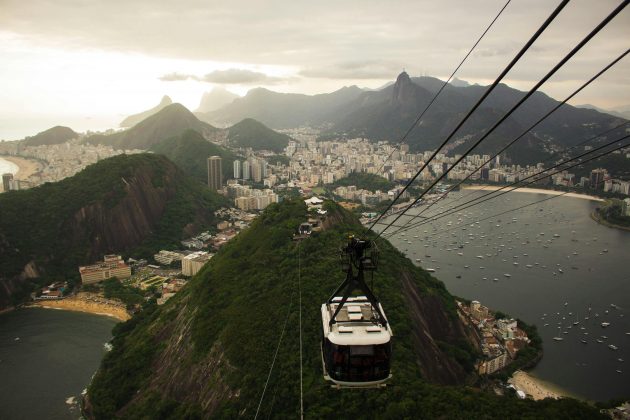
left=0, top=0, right=630, bottom=139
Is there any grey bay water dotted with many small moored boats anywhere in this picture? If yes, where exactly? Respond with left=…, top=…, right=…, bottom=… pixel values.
left=391, top=190, right=630, bottom=400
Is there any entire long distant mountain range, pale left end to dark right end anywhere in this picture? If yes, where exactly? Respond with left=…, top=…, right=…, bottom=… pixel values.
left=202, top=72, right=623, bottom=163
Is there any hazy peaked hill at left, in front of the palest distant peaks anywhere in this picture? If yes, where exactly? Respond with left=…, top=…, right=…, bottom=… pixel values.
left=87, top=103, right=220, bottom=150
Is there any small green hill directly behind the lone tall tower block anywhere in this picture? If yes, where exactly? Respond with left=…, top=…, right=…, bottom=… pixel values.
left=151, top=130, right=237, bottom=183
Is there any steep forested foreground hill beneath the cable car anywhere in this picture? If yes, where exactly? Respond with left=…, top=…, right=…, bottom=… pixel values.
left=85, top=201, right=599, bottom=419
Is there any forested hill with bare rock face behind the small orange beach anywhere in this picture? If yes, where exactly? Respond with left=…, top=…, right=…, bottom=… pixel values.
left=0, top=154, right=224, bottom=309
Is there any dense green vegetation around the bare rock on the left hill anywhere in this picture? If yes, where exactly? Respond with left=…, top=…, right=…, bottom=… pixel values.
left=0, top=154, right=224, bottom=306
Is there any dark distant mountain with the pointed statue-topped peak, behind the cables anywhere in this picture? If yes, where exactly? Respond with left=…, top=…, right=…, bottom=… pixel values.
left=324, top=72, right=621, bottom=163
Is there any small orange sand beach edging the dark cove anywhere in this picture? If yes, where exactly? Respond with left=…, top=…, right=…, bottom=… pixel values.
left=29, top=292, right=131, bottom=321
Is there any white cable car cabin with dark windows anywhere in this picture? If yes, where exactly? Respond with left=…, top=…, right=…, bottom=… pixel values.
left=322, top=296, right=393, bottom=388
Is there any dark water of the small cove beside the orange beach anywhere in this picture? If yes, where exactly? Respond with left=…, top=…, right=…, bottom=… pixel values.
left=0, top=308, right=116, bottom=420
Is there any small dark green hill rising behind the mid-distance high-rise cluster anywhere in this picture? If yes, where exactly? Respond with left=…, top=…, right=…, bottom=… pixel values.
left=228, top=118, right=291, bottom=153
